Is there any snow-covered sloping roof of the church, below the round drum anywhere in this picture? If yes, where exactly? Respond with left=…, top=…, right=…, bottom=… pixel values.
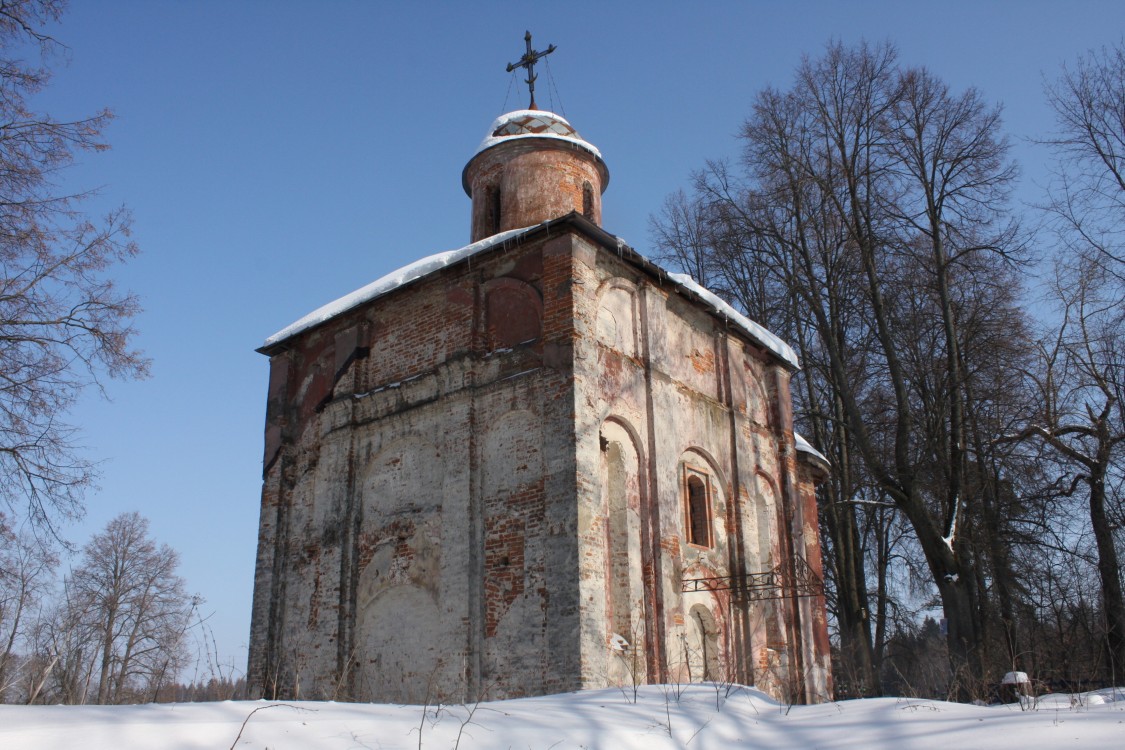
left=261, top=217, right=801, bottom=373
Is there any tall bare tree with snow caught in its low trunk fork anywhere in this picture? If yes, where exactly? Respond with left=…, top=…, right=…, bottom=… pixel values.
left=884, top=69, right=1027, bottom=692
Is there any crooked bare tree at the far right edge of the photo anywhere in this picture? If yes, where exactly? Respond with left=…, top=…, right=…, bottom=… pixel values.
left=1022, top=36, right=1125, bottom=678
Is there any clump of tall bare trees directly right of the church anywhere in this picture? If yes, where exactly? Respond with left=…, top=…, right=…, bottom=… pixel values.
left=655, top=44, right=1029, bottom=697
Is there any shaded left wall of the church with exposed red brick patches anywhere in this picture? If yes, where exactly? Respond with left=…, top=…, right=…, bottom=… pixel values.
left=250, top=230, right=577, bottom=702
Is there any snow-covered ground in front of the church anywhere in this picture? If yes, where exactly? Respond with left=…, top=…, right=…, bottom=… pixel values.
left=0, top=685, right=1125, bottom=750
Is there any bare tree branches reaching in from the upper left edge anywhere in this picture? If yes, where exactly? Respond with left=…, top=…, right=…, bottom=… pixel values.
left=0, top=0, right=147, bottom=532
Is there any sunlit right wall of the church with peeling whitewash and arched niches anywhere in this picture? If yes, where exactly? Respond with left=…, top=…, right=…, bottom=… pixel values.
left=575, top=239, right=805, bottom=687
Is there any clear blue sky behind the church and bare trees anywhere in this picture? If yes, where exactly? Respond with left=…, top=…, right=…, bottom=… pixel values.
left=30, top=0, right=1125, bottom=669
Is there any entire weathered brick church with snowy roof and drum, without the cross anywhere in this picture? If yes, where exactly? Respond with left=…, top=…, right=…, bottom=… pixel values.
left=249, top=110, right=831, bottom=702
